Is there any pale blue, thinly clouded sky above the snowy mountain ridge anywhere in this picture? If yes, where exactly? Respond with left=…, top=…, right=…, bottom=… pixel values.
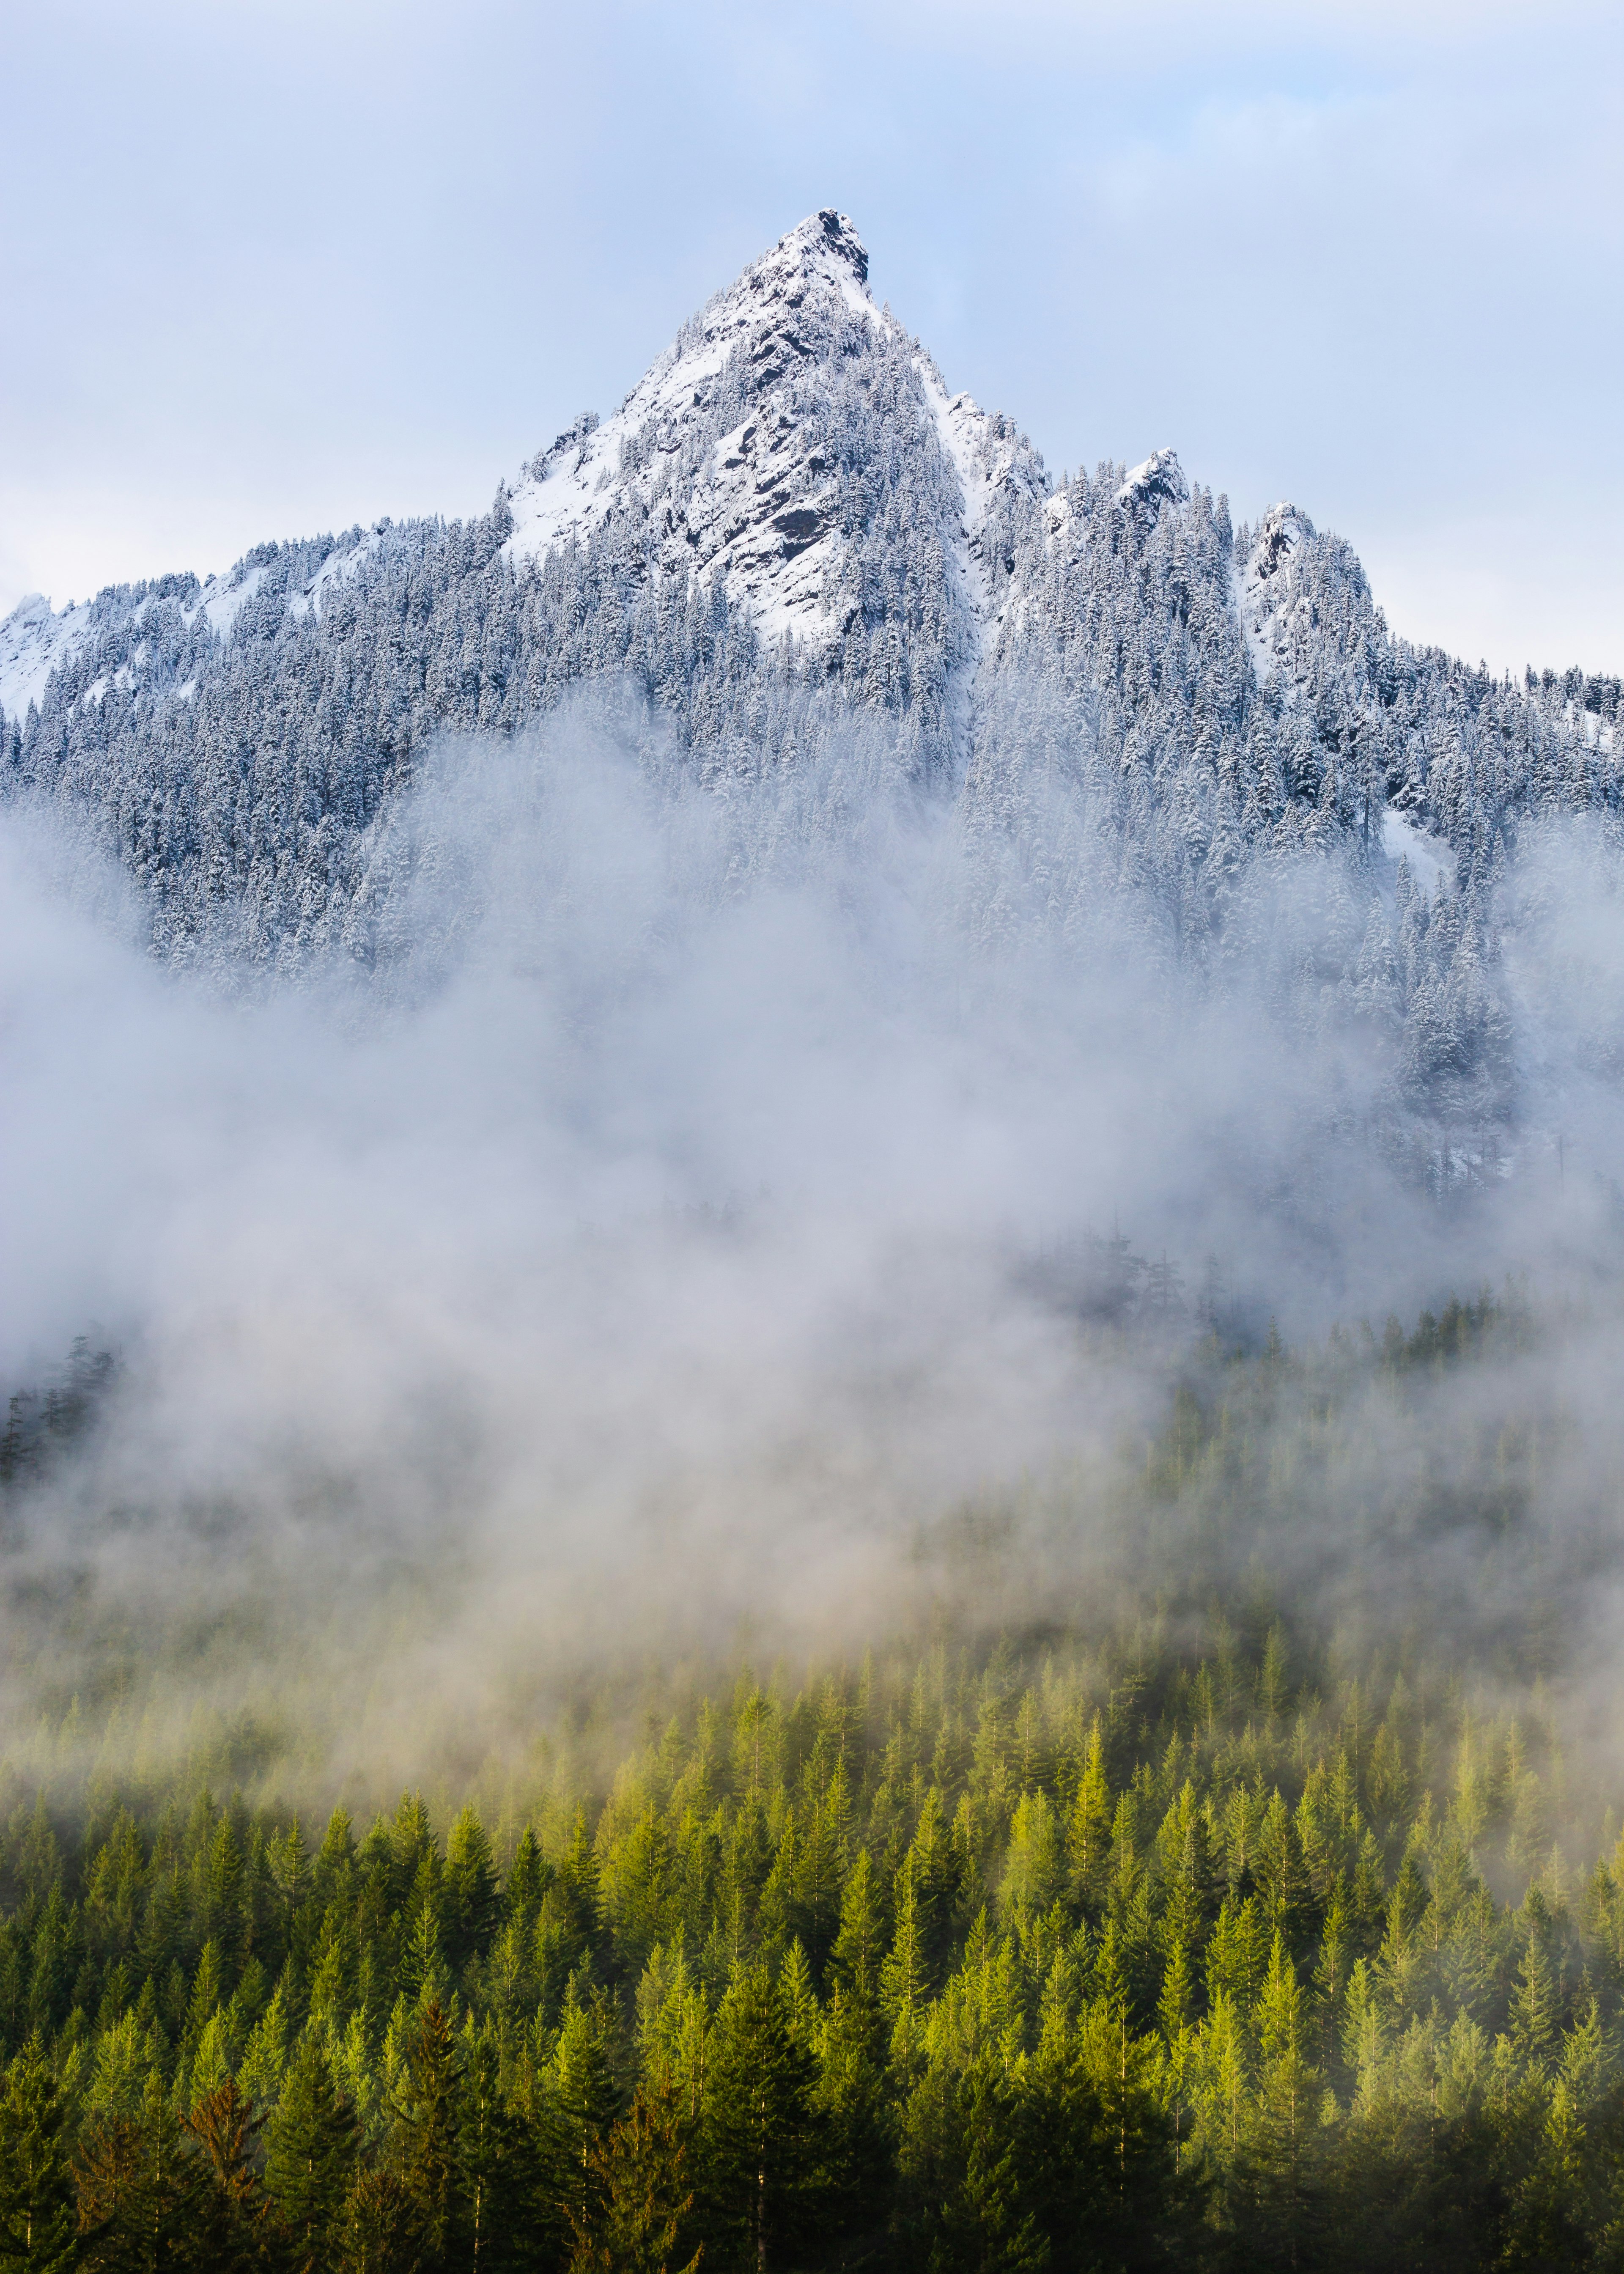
left=0, top=0, right=1624, bottom=671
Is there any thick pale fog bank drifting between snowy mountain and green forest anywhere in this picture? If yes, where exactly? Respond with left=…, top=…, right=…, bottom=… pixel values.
left=0, top=714, right=1624, bottom=1776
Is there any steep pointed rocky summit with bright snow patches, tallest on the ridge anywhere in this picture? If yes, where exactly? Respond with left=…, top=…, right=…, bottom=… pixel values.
left=505, top=211, right=1048, bottom=718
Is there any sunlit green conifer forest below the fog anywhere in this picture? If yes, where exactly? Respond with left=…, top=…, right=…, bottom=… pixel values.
left=0, top=1289, right=1624, bottom=2274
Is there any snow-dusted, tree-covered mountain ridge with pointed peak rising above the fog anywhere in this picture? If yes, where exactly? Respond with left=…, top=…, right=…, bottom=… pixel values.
left=0, top=211, right=1624, bottom=1114
